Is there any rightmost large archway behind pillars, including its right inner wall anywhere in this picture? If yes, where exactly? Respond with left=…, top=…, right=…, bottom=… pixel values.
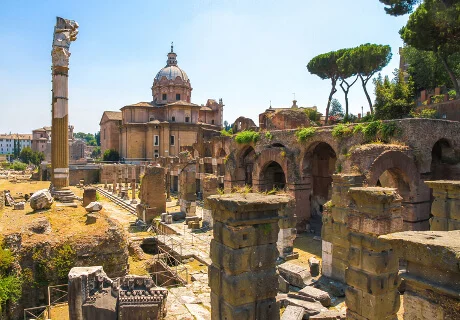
left=367, top=151, right=431, bottom=230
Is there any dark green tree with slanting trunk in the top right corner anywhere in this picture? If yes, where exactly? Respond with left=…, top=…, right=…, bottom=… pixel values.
left=399, top=0, right=460, bottom=98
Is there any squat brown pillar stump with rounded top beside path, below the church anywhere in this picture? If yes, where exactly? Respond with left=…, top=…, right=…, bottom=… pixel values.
left=139, top=166, right=166, bottom=222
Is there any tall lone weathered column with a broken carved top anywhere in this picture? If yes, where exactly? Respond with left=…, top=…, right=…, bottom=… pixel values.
left=51, top=17, right=78, bottom=190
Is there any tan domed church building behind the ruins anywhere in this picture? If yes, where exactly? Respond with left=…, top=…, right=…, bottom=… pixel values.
left=100, top=46, right=224, bottom=161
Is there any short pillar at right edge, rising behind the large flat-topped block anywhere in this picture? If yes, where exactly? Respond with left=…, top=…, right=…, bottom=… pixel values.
left=425, top=180, right=460, bottom=231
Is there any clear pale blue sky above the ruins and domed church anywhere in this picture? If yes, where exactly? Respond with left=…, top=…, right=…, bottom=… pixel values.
left=0, top=0, right=407, bottom=133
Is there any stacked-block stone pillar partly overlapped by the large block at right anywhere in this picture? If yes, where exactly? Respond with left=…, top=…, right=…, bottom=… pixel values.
left=345, top=187, right=403, bottom=320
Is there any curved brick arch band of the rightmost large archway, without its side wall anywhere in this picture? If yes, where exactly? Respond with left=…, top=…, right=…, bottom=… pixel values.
left=366, top=150, right=420, bottom=200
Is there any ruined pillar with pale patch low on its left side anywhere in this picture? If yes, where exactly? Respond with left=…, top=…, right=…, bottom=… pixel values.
left=321, top=174, right=364, bottom=282
